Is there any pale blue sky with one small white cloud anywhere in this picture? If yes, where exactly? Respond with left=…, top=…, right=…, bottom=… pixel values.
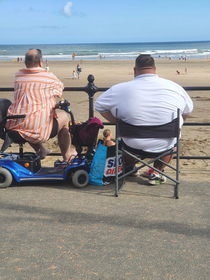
left=0, top=0, right=210, bottom=45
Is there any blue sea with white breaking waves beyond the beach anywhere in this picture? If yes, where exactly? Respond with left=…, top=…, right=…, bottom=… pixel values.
left=0, top=41, right=210, bottom=60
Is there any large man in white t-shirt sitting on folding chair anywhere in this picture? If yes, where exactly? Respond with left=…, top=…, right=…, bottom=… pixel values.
left=95, top=54, right=193, bottom=184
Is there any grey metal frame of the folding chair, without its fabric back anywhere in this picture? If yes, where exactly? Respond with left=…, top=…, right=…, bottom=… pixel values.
left=115, top=109, right=180, bottom=199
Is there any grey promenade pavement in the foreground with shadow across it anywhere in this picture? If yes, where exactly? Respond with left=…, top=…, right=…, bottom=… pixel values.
left=0, top=168, right=210, bottom=280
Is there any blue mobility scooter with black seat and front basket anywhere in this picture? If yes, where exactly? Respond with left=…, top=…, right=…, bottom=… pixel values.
left=0, top=99, right=103, bottom=188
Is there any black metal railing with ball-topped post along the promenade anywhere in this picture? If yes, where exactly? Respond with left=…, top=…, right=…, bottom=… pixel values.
left=0, top=75, right=210, bottom=159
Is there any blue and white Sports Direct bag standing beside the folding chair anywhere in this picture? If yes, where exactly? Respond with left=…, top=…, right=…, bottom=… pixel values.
left=89, top=141, right=123, bottom=186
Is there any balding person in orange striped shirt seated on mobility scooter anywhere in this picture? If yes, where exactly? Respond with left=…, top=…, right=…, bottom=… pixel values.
left=6, top=49, right=77, bottom=162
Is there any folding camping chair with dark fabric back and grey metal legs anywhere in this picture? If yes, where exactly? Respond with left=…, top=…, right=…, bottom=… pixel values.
left=115, top=109, right=180, bottom=199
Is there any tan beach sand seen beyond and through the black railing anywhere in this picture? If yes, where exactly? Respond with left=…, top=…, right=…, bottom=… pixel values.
left=0, top=59, right=210, bottom=182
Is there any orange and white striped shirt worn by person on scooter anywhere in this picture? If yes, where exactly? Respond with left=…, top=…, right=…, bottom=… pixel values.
left=6, top=67, right=64, bottom=143
